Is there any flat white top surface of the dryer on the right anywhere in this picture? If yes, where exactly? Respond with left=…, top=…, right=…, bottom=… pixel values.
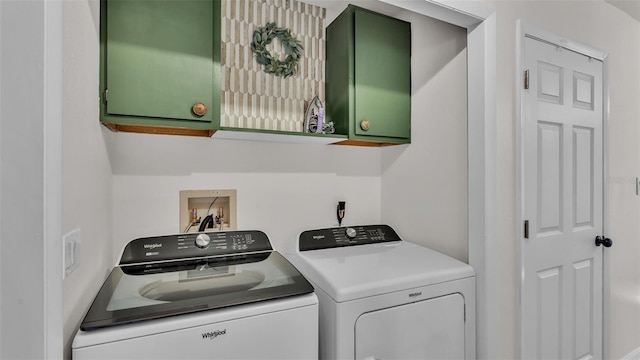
left=290, top=241, right=475, bottom=302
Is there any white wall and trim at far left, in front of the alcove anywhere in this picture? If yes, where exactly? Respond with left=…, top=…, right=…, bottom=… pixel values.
left=0, top=1, right=62, bottom=359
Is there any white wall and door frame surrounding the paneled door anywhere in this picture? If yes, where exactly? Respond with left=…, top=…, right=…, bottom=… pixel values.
left=484, top=1, right=640, bottom=359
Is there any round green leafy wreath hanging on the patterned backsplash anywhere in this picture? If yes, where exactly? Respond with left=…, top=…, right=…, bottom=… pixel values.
left=251, top=22, right=303, bottom=78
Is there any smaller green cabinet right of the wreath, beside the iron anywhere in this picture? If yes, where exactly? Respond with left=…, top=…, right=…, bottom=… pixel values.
left=326, top=5, right=411, bottom=145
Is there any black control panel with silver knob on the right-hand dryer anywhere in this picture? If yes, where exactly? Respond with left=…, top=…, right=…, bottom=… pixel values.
left=298, top=225, right=402, bottom=251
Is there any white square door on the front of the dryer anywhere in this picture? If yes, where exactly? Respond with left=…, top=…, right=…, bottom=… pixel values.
left=355, top=293, right=465, bottom=360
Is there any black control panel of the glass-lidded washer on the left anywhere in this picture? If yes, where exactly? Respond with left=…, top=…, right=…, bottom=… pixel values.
left=120, top=230, right=273, bottom=265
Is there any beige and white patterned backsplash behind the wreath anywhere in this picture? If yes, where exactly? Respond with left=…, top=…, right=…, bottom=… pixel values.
left=220, top=0, right=326, bottom=131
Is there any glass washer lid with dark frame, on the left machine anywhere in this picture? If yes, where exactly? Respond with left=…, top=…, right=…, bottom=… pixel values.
left=80, top=251, right=313, bottom=330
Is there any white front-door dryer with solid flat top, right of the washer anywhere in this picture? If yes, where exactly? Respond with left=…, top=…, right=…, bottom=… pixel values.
left=288, top=225, right=476, bottom=360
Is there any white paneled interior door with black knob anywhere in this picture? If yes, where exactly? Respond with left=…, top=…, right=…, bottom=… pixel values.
left=521, top=37, right=604, bottom=359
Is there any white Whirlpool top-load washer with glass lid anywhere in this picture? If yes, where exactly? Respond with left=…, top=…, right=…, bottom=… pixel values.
left=72, top=231, right=318, bottom=360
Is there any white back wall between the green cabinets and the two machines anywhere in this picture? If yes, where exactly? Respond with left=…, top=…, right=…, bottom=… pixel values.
left=109, top=133, right=380, bottom=256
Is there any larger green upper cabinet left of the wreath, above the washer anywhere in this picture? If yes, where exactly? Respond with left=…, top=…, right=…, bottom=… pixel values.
left=100, top=0, right=220, bottom=136
